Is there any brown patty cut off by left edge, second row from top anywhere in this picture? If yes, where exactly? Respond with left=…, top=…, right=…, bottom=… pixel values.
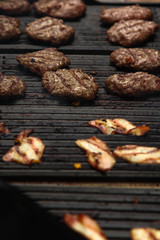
left=0, top=15, right=21, bottom=42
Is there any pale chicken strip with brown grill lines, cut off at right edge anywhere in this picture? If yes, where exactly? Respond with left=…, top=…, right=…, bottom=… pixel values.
left=114, top=145, right=160, bottom=164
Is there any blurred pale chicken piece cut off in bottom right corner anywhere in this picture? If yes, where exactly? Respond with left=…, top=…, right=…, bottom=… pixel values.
left=130, top=228, right=160, bottom=240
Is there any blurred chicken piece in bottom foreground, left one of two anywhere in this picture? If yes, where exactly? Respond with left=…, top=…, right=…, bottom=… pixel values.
left=64, top=213, right=107, bottom=240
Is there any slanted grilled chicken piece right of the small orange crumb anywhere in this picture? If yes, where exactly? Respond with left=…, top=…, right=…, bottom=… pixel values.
left=76, top=136, right=116, bottom=172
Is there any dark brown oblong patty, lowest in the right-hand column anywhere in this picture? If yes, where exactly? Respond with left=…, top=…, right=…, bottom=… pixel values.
left=105, top=72, right=160, bottom=97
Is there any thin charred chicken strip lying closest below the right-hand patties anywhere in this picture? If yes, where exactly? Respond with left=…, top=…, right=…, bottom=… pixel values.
left=89, top=118, right=150, bottom=136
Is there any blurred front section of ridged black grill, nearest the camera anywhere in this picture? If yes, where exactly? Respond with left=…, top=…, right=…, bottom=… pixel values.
left=11, top=184, right=160, bottom=240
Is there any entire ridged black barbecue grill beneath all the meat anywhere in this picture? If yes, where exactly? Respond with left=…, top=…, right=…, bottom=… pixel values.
left=0, top=1, right=160, bottom=237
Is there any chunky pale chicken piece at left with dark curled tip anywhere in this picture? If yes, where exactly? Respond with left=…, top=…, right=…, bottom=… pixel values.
left=2, top=129, right=45, bottom=165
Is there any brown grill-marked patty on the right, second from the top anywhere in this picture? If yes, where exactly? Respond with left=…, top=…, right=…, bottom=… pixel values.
left=106, top=20, right=158, bottom=47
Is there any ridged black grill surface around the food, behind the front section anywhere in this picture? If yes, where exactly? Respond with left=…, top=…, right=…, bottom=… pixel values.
left=0, top=5, right=160, bottom=181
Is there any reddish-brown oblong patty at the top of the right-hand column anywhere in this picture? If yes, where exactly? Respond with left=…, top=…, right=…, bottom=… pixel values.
left=101, top=4, right=153, bottom=24
